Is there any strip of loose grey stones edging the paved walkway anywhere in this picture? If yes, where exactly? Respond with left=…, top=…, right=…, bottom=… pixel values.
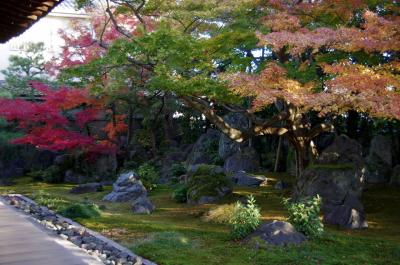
left=0, top=194, right=156, bottom=265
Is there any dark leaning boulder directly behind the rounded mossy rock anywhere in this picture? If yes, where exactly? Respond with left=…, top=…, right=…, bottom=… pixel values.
left=186, top=129, right=220, bottom=165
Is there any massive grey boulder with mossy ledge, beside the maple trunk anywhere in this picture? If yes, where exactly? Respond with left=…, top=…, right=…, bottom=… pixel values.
left=294, top=135, right=367, bottom=229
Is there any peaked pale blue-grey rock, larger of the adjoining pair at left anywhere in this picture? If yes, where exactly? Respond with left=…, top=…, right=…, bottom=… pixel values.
left=103, top=171, right=147, bottom=202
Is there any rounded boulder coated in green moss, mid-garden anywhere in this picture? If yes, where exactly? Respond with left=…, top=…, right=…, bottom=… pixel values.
left=187, top=165, right=232, bottom=204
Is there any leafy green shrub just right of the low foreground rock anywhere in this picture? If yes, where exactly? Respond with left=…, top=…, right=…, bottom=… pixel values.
left=283, top=195, right=324, bottom=237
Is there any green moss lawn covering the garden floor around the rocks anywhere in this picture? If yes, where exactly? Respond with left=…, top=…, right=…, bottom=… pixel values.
left=0, top=175, right=400, bottom=265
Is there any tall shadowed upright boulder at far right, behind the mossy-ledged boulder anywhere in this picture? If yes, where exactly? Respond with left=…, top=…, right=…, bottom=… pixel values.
left=365, top=135, right=392, bottom=184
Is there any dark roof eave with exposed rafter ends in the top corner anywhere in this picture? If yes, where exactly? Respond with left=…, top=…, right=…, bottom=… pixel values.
left=0, top=0, right=63, bottom=43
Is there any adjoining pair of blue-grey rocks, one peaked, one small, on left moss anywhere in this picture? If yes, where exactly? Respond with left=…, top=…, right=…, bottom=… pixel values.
left=103, top=171, right=155, bottom=214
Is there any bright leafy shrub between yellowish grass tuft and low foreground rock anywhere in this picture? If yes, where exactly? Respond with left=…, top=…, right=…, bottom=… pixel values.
left=229, top=196, right=261, bottom=240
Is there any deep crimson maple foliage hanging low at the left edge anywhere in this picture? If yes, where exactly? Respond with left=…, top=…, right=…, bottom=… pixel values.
left=0, top=82, right=126, bottom=154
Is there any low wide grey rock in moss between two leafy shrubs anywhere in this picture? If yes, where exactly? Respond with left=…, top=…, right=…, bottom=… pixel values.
left=248, top=221, right=307, bottom=246
